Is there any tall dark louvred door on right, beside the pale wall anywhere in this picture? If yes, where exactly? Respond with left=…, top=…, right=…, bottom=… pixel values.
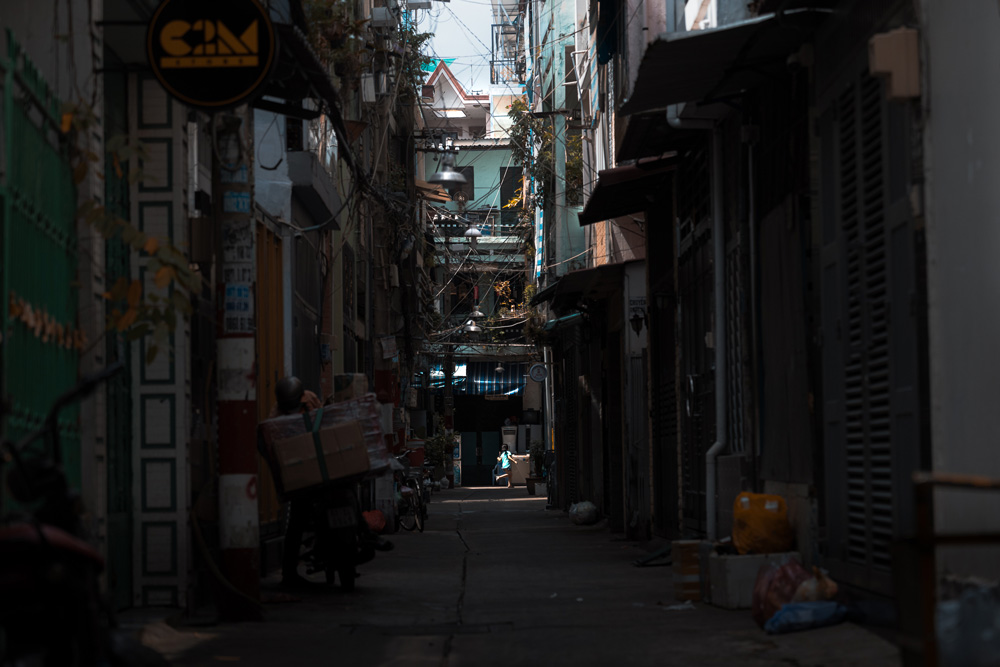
left=821, top=74, right=921, bottom=592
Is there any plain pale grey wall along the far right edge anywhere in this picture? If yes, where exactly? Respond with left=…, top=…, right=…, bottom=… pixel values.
left=921, top=0, right=1000, bottom=578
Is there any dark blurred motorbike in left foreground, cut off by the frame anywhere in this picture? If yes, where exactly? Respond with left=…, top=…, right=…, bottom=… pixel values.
left=0, top=364, right=167, bottom=667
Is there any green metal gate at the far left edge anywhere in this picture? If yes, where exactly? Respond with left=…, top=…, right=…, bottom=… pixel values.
left=0, top=29, right=82, bottom=504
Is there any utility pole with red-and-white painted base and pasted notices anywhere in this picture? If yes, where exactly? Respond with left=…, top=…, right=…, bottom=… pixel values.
left=212, top=107, right=260, bottom=620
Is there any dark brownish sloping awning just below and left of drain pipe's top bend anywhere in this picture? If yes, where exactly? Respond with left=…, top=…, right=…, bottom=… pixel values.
left=579, top=153, right=677, bottom=225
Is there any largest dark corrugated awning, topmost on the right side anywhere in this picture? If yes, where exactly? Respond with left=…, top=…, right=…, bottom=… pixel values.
left=621, top=8, right=831, bottom=115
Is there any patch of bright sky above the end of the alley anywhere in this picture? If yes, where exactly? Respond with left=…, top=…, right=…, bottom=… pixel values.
left=416, top=0, right=492, bottom=93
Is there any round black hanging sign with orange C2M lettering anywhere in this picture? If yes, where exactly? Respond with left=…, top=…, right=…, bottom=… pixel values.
left=146, top=0, right=275, bottom=110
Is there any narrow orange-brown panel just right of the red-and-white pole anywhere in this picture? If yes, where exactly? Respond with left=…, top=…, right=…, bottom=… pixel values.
left=254, top=223, right=285, bottom=538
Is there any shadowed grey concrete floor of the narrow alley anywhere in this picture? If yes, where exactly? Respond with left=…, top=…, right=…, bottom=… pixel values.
left=142, top=487, right=900, bottom=667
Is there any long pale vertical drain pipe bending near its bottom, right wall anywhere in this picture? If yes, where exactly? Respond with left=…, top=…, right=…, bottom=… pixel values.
left=705, top=129, right=728, bottom=540
